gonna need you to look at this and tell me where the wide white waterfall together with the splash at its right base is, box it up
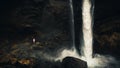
[82,0,117,68]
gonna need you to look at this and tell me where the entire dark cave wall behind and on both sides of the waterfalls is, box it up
[0,0,120,66]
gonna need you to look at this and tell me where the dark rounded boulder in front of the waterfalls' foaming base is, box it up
[62,57,87,68]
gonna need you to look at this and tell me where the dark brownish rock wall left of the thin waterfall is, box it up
[0,0,72,62]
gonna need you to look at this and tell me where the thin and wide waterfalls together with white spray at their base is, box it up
[55,0,117,68]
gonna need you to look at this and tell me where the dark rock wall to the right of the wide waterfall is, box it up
[93,0,120,56]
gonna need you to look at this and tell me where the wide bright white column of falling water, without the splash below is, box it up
[82,0,93,61]
